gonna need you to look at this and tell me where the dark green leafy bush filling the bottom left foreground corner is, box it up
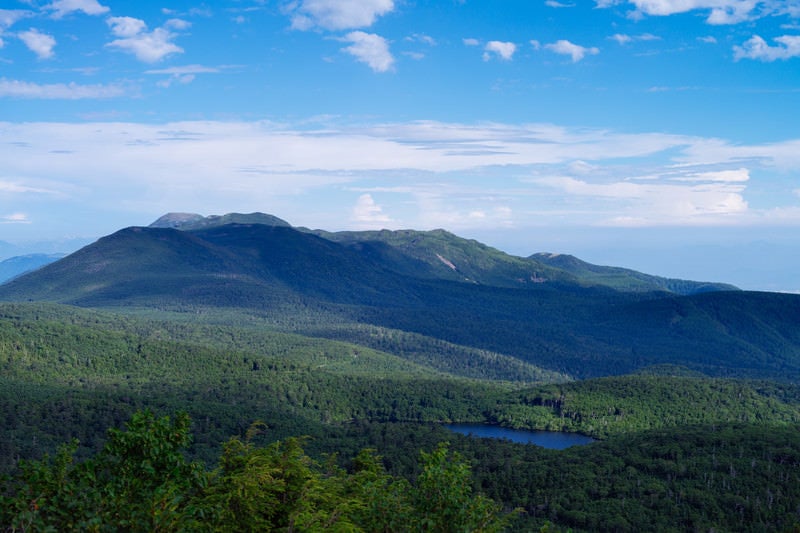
[0,411,206,531]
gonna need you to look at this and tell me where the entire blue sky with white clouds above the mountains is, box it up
[0,0,800,292]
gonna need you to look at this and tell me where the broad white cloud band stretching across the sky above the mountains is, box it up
[0,119,800,228]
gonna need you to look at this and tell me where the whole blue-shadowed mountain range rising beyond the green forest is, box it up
[0,213,800,379]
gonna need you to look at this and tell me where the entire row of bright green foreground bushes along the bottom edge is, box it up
[0,412,509,532]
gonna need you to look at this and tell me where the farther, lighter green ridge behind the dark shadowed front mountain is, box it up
[148,212,739,295]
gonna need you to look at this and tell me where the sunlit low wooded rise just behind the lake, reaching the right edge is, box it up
[491,375,800,437]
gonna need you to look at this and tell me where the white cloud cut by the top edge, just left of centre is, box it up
[288,0,394,31]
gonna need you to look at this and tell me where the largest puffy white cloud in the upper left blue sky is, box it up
[106,17,183,63]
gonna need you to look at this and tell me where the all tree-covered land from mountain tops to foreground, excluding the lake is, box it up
[0,216,800,532]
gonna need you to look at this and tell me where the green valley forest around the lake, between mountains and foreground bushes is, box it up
[0,304,800,531]
